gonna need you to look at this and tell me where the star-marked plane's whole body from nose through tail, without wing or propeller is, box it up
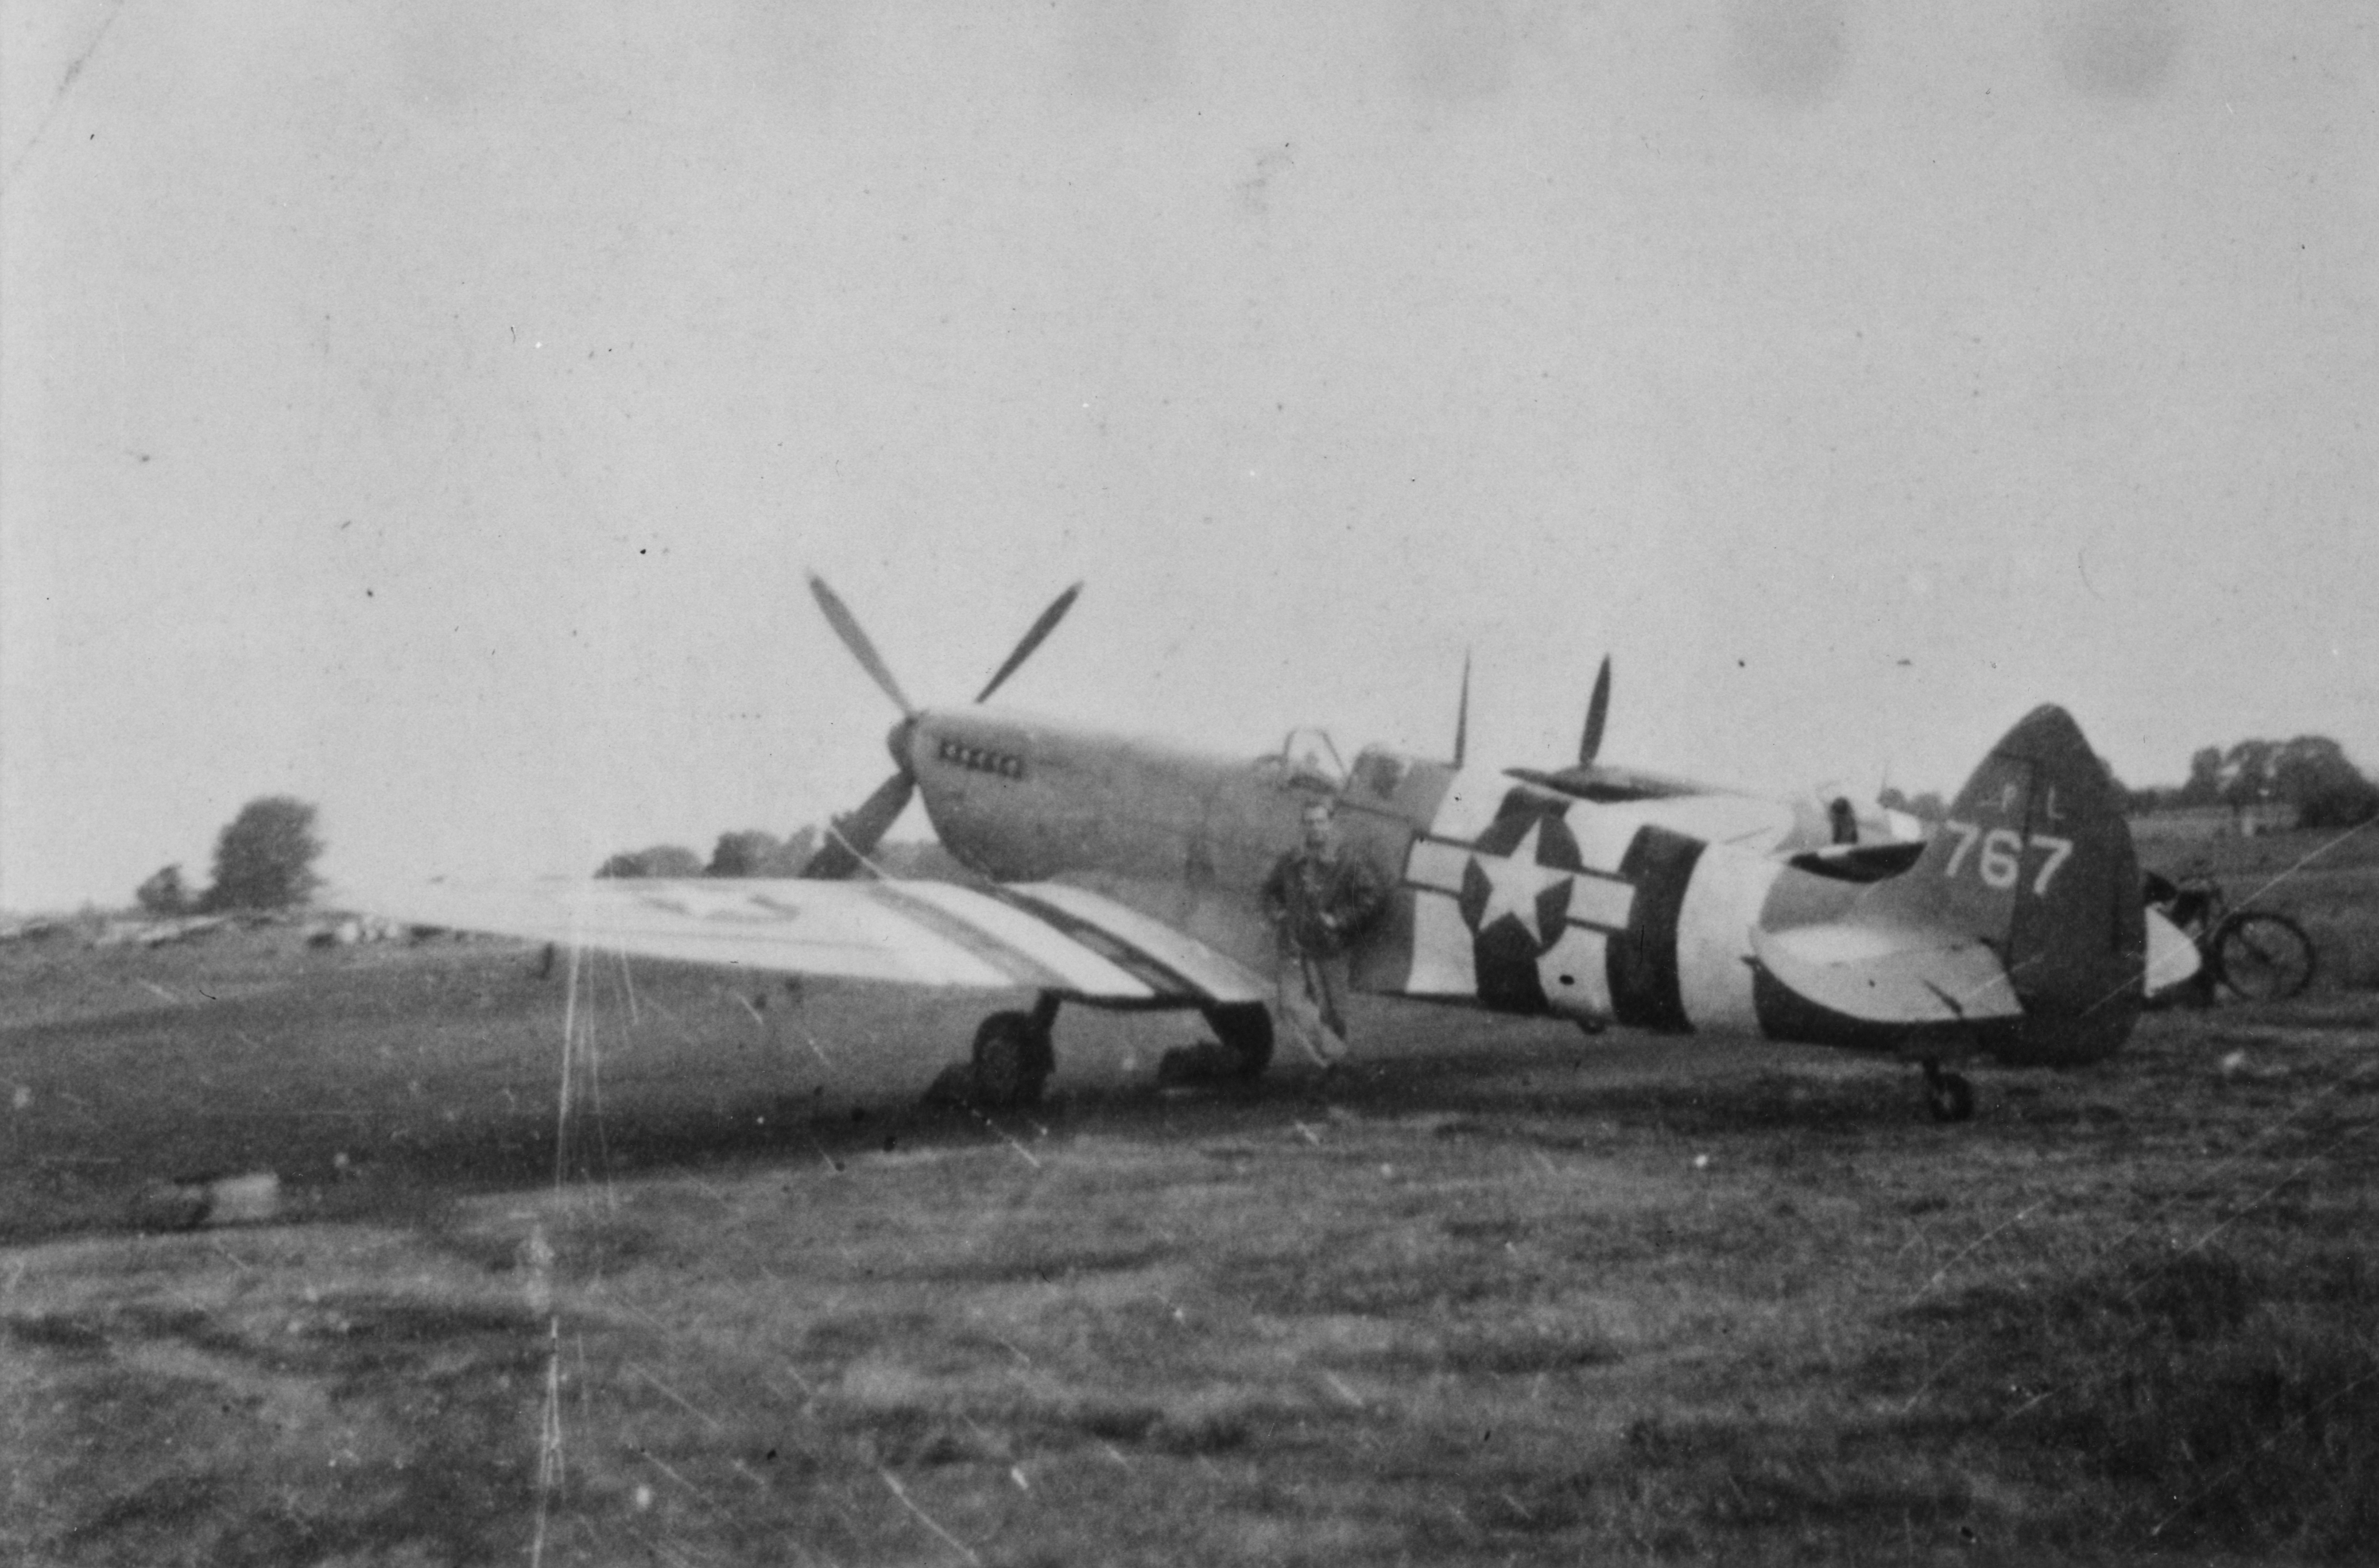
[897,707,2148,1064]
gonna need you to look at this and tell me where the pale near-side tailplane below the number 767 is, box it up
[1751,923,2024,1028]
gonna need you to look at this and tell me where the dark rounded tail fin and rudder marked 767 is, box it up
[1851,707,2148,1064]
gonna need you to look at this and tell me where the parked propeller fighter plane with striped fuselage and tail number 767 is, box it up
[371,576,2196,1121]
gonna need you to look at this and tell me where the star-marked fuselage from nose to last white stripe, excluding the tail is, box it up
[909,707,1903,1056]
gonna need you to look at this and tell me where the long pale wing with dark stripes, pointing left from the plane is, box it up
[340,878,1270,1006]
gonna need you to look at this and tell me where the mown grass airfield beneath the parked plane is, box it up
[0,840,2379,1566]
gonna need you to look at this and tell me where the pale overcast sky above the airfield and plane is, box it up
[0,0,2379,909]
